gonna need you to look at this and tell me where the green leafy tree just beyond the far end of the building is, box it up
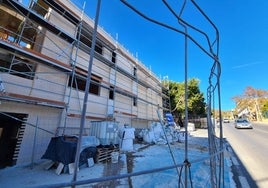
[169,78,206,121]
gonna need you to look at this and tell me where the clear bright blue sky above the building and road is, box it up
[73,0,268,110]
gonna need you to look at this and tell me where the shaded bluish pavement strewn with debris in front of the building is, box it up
[0,129,233,188]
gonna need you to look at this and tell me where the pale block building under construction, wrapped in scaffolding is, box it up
[0,0,169,168]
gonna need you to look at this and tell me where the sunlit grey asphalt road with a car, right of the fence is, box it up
[223,122,268,188]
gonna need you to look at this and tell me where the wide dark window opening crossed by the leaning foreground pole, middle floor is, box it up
[68,72,101,95]
